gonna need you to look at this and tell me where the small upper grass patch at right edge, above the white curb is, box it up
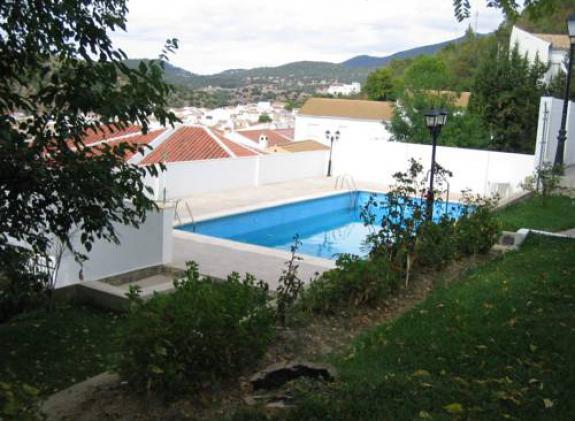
[498,195,575,231]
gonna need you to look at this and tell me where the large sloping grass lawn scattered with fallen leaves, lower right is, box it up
[278,237,575,421]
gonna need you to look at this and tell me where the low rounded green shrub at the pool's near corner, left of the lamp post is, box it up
[302,254,399,313]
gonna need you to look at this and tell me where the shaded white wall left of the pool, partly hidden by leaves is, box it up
[56,207,174,288]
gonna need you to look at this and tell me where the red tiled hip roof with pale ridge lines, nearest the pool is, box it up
[140,126,256,165]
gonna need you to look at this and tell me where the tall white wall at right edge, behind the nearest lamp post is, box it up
[535,97,575,166]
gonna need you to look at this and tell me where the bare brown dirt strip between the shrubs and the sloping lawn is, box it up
[40,251,493,421]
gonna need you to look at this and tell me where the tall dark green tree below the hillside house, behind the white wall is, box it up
[470,44,546,153]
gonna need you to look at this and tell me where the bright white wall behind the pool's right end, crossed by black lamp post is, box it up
[333,141,534,195]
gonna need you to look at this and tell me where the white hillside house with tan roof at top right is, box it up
[509,26,569,83]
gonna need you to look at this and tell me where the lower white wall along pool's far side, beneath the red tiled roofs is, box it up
[145,151,329,200]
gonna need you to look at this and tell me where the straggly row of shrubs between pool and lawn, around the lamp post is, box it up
[302,160,500,313]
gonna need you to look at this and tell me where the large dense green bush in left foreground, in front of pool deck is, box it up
[120,262,274,395]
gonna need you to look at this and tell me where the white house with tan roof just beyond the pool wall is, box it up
[294,98,394,145]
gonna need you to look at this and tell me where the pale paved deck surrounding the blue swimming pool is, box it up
[172,177,387,290]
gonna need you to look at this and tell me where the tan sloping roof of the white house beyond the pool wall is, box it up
[299,98,394,121]
